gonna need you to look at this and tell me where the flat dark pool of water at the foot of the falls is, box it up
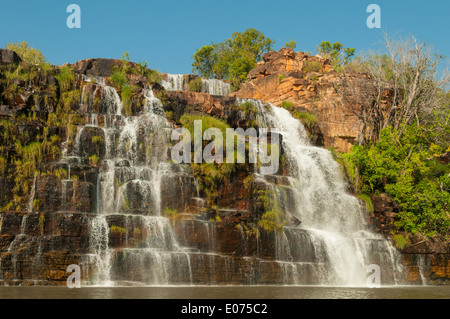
[0,286,450,299]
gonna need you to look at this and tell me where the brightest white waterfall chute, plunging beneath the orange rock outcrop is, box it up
[268,105,398,286]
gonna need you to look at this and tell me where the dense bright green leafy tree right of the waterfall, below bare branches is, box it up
[341,122,450,239]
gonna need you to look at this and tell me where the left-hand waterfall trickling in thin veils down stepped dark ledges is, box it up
[63,77,192,286]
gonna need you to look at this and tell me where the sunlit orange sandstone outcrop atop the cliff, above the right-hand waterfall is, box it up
[231,48,370,152]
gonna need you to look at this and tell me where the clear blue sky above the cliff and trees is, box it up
[0,0,450,73]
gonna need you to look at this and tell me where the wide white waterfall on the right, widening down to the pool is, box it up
[243,100,408,286]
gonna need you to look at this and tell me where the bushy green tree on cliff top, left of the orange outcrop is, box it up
[192,28,275,85]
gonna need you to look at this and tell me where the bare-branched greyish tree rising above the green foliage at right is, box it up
[340,35,449,144]
